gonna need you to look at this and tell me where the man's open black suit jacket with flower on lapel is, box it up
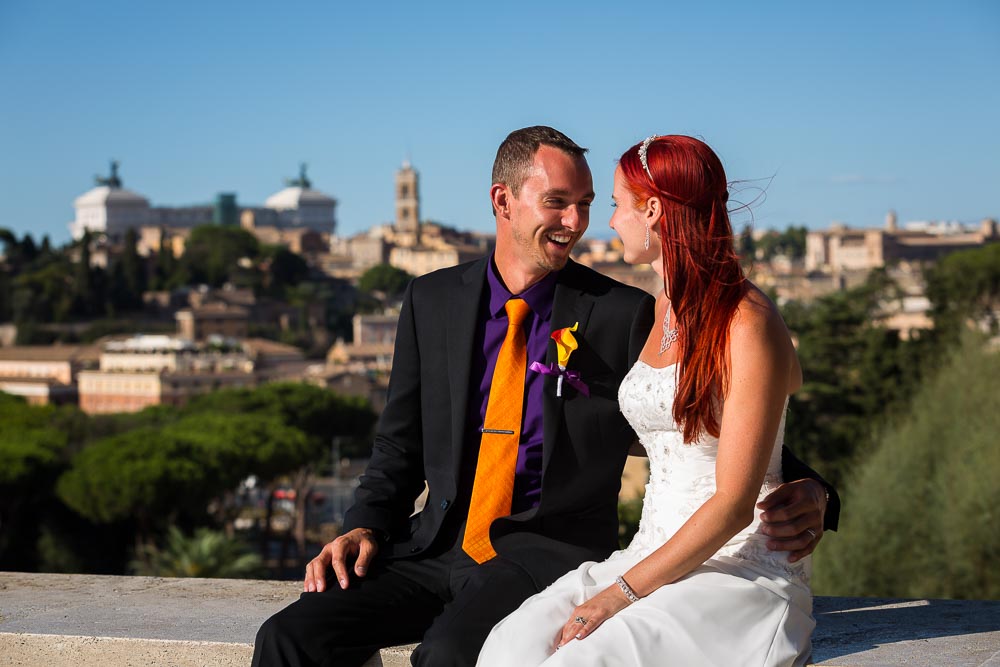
[344,257,840,588]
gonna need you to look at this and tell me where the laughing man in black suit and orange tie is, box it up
[253,127,838,666]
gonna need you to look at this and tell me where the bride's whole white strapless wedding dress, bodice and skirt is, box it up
[478,361,815,667]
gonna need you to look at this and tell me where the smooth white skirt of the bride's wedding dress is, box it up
[478,552,815,667]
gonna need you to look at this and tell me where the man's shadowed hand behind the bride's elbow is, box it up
[757,479,826,563]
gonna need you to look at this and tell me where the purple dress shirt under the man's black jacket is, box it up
[466,259,558,514]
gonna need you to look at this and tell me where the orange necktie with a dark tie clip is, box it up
[462,299,531,563]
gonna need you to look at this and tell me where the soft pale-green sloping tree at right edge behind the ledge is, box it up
[814,334,1000,599]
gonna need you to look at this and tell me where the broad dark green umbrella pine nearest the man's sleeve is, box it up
[56,383,374,568]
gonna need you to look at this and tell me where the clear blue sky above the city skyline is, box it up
[0,0,1000,242]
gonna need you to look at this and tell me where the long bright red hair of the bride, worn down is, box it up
[619,135,748,443]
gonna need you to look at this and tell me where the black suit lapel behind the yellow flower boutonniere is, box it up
[542,261,594,475]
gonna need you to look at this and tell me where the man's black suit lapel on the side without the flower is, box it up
[445,256,489,484]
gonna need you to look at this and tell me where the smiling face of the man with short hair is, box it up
[498,146,594,271]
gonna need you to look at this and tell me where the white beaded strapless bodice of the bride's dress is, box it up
[618,361,808,584]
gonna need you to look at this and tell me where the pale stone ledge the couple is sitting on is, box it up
[0,572,1000,667]
